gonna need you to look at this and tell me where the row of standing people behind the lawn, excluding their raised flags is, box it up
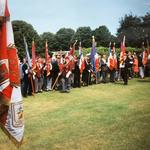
[20,49,150,97]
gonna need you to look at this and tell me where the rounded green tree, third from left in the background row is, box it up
[55,28,75,51]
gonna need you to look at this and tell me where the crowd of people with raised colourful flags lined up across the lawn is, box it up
[20,36,150,97]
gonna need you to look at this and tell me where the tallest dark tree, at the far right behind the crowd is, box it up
[117,13,150,47]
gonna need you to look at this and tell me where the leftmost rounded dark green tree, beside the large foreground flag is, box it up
[12,20,41,57]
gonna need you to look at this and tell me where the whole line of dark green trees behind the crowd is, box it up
[13,13,150,57]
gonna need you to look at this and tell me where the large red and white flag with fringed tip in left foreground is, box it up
[0,0,24,147]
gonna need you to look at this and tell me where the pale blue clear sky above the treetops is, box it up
[8,0,150,35]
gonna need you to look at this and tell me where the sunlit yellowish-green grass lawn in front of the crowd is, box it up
[0,78,150,150]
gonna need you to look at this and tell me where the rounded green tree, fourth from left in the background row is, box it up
[73,27,92,48]
